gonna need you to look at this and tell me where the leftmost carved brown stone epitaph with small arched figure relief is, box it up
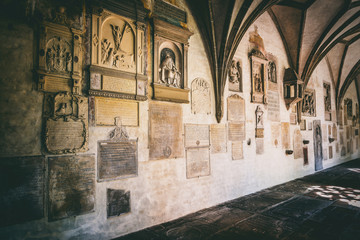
[37,22,82,94]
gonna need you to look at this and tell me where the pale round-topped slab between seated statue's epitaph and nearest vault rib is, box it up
[191,78,211,114]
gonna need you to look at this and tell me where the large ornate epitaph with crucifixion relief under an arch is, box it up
[89,6,147,101]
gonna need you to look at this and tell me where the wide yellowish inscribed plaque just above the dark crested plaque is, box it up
[95,97,139,126]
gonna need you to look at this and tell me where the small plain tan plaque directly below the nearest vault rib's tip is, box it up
[210,124,227,153]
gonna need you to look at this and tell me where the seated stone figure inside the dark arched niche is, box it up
[159,48,181,88]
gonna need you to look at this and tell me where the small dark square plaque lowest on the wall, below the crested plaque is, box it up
[106,188,131,218]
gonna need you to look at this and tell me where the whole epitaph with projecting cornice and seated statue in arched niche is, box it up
[152,16,192,103]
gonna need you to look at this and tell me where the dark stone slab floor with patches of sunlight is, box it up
[117,159,360,240]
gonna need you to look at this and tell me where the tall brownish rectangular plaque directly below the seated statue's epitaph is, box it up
[149,102,183,160]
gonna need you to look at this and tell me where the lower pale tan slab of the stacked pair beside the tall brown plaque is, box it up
[186,147,210,178]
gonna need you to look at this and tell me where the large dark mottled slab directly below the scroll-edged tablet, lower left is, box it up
[48,155,95,221]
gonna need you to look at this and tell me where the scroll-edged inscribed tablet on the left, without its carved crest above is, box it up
[45,117,88,154]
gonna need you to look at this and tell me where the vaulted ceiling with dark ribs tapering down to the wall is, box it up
[186,0,360,122]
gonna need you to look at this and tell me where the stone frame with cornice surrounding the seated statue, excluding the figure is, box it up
[152,18,193,103]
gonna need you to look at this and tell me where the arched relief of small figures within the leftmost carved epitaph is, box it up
[46,37,72,72]
